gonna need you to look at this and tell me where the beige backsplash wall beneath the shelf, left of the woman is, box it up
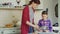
[0,10,22,27]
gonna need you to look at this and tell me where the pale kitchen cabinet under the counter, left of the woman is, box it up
[0,27,20,34]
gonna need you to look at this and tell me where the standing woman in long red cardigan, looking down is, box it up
[21,0,40,34]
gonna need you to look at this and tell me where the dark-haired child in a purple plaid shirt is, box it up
[38,11,52,32]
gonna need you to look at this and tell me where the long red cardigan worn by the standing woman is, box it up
[21,6,35,34]
